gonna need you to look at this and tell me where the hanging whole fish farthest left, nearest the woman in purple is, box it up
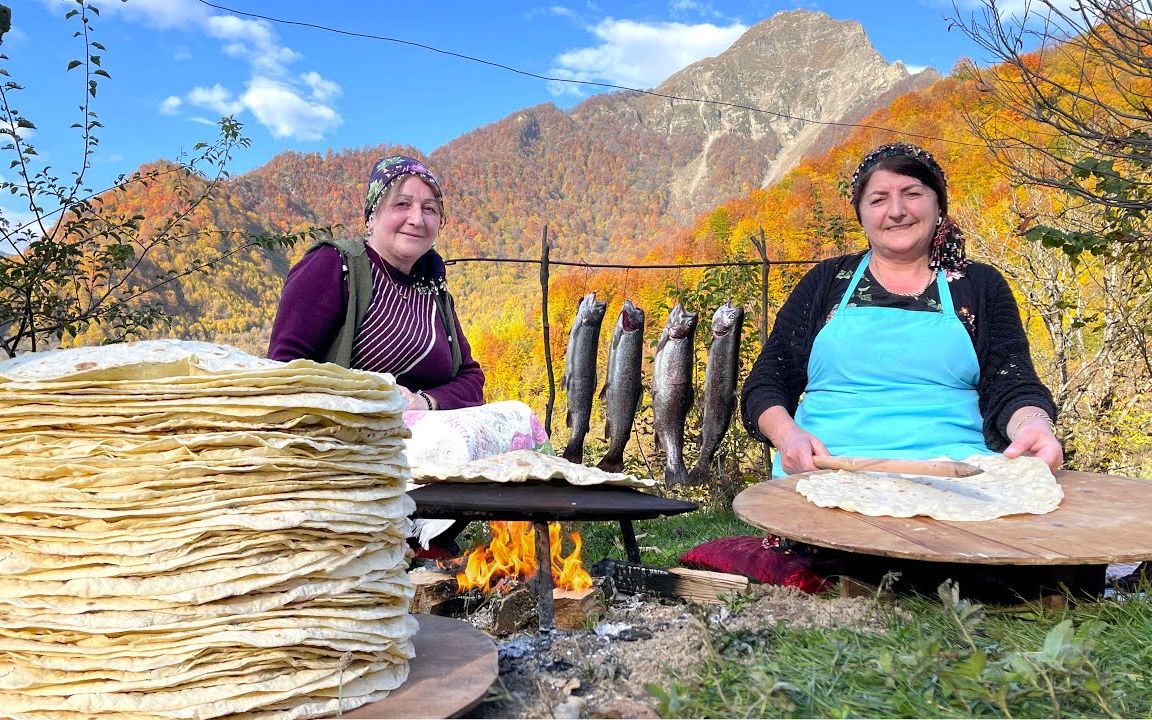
[560,293,607,463]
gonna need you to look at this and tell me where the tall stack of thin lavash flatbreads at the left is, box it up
[0,341,417,720]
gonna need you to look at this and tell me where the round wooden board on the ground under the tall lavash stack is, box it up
[331,615,499,720]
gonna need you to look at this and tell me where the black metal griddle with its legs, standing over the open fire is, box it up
[408,482,698,630]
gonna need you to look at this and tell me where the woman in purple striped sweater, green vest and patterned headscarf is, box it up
[268,156,484,410]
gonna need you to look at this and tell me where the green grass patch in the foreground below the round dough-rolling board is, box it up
[649,586,1152,718]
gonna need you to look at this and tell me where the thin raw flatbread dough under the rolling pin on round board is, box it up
[796,455,1064,521]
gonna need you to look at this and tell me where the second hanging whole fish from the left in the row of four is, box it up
[597,300,644,472]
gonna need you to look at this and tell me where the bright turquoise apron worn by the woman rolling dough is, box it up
[773,252,992,477]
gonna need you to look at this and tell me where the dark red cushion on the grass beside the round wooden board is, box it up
[680,535,831,592]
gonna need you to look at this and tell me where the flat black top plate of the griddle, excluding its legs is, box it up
[408,483,697,522]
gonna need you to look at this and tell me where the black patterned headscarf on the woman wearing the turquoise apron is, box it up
[852,143,971,278]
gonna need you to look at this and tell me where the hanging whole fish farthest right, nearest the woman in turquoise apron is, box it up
[688,302,744,485]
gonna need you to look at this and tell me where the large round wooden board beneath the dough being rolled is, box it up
[733,470,1152,566]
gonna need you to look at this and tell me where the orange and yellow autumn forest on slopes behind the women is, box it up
[4,7,1152,484]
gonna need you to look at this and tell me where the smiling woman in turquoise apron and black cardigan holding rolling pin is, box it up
[742,143,1063,477]
